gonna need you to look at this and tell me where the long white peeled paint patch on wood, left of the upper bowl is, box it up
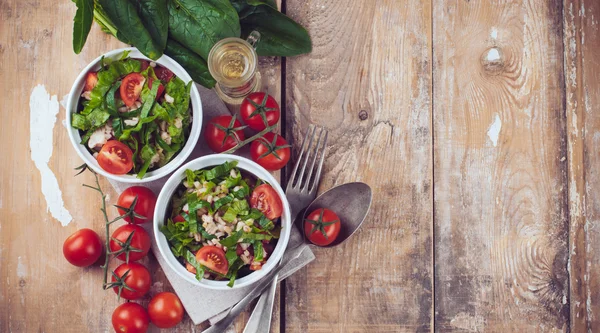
[29,84,73,226]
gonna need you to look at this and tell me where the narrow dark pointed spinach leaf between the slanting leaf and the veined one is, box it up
[131,0,169,50]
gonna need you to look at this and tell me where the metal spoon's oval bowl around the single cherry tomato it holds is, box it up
[301,182,373,247]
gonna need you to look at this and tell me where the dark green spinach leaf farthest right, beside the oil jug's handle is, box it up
[240,4,312,57]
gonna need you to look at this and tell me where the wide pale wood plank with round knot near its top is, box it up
[433,0,569,332]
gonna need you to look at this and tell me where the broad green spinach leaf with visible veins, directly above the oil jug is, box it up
[168,0,240,59]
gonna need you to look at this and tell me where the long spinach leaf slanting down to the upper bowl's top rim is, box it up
[98,0,164,60]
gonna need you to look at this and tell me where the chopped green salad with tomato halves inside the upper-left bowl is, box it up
[71,52,192,179]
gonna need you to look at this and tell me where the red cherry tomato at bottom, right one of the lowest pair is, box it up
[148,292,183,328]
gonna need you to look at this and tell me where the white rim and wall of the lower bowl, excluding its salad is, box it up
[153,154,292,290]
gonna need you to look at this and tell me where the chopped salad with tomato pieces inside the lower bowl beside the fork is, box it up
[161,162,283,287]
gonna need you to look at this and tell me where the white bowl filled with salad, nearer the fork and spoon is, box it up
[155,155,290,288]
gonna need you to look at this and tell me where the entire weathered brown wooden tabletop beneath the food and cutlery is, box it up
[0,0,600,333]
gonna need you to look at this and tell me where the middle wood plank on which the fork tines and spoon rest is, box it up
[285,0,432,333]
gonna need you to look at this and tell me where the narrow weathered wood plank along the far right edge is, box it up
[563,0,600,332]
